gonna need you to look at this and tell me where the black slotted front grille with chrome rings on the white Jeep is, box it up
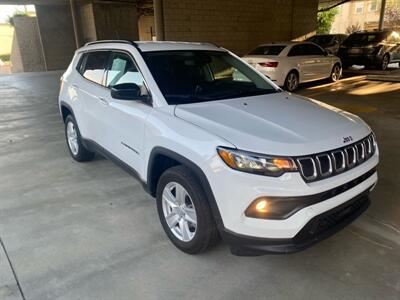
[296,134,376,182]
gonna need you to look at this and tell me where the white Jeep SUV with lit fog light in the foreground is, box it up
[59,41,378,255]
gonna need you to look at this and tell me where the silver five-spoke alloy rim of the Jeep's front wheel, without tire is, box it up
[162,182,197,242]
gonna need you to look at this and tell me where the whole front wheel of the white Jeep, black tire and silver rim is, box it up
[156,166,218,254]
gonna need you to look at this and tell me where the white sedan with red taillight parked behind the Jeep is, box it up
[243,42,342,92]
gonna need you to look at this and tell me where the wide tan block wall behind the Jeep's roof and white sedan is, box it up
[163,0,318,54]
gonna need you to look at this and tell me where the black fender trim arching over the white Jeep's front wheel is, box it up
[147,147,225,231]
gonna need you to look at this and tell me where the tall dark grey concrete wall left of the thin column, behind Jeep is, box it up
[35,4,76,71]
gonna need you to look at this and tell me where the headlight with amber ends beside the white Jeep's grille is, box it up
[217,147,297,177]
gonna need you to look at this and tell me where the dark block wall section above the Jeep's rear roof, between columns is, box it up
[92,2,139,40]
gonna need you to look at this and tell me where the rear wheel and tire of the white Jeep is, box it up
[64,115,94,162]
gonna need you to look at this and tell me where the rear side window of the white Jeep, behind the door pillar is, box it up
[81,51,110,84]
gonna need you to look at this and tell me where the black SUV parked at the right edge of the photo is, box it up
[338,30,400,70]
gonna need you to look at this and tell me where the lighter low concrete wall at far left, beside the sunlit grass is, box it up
[11,16,46,73]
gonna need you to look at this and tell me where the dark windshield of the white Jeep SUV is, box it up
[143,50,279,104]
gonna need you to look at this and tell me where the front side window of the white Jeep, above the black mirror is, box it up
[106,52,146,94]
